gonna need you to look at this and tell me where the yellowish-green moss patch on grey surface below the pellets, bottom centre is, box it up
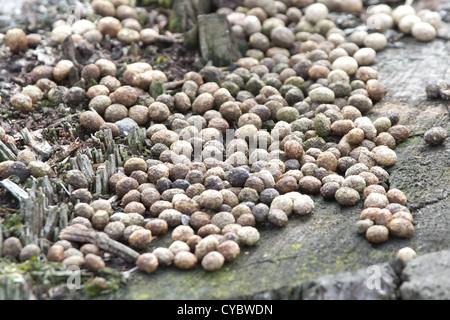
[116,235,400,299]
